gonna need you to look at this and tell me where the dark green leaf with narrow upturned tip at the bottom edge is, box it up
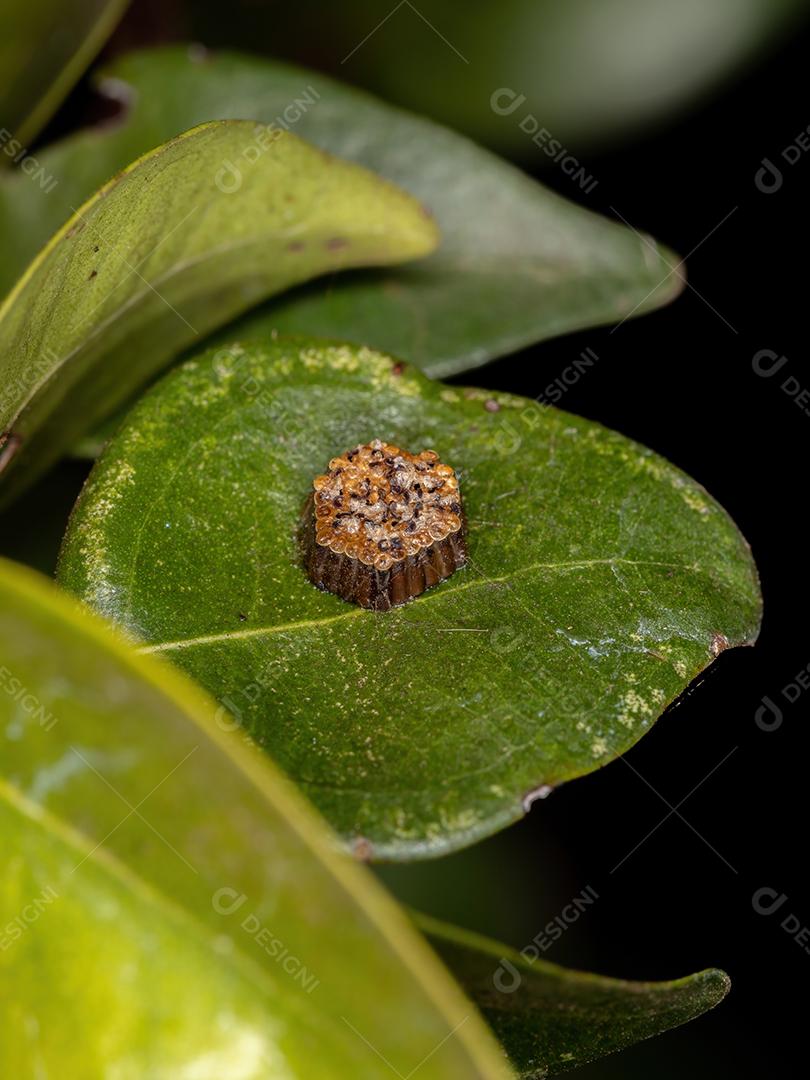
[416,915,730,1080]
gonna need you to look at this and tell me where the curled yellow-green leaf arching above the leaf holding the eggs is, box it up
[0,121,436,499]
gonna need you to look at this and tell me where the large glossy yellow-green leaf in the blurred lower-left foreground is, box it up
[0,561,505,1080]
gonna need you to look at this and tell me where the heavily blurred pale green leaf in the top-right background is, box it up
[328,0,808,157]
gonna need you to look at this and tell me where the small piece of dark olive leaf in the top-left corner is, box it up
[0,0,127,152]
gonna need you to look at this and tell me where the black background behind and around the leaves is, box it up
[2,0,810,1080]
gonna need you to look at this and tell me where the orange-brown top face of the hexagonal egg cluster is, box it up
[313,438,463,570]
